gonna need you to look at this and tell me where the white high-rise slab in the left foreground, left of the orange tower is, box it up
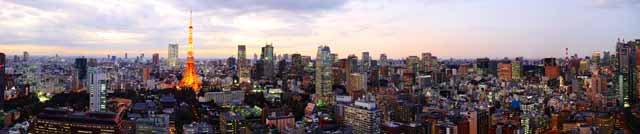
[87,67,108,112]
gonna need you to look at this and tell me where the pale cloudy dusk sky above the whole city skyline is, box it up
[0,0,640,59]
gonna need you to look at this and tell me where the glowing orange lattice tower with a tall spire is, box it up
[180,10,200,94]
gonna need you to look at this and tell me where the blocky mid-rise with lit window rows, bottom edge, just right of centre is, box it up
[344,97,382,134]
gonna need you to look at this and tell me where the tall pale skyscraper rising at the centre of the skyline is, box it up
[315,46,333,104]
